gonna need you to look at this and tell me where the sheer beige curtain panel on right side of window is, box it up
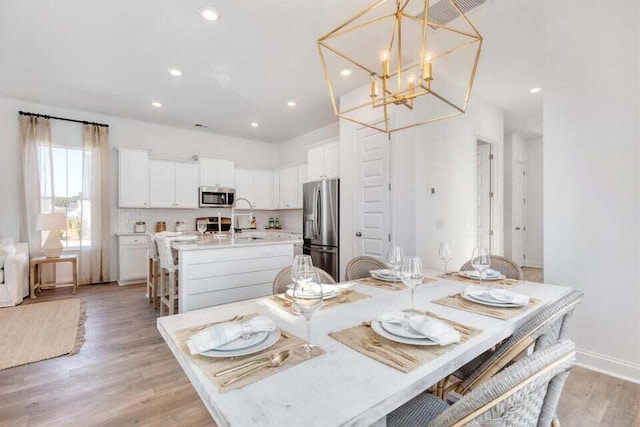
[78,124,111,284]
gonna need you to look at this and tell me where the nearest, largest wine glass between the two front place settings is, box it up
[292,271,324,358]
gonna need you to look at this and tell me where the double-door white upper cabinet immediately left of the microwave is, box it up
[149,160,199,209]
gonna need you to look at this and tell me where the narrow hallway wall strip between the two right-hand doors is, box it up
[504,133,529,259]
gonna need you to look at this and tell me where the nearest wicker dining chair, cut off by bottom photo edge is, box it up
[387,340,576,427]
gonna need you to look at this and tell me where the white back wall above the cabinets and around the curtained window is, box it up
[0,97,277,280]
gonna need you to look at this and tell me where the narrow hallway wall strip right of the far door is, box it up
[524,138,544,268]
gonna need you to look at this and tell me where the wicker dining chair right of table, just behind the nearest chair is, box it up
[436,290,584,398]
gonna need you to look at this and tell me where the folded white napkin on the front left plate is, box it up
[187,316,276,354]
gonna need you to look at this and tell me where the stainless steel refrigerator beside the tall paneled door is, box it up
[302,179,340,282]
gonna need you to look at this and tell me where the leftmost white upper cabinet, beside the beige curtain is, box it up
[118,148,149,208]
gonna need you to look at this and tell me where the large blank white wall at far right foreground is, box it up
[541,0,640,381]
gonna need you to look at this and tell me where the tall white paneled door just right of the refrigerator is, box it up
[353,128,391,259]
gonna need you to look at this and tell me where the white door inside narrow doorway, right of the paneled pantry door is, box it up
[476,141,491,253]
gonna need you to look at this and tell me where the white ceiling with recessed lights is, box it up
[0,0,542,143]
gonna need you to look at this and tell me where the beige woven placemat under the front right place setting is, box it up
[329,312,482,372]
